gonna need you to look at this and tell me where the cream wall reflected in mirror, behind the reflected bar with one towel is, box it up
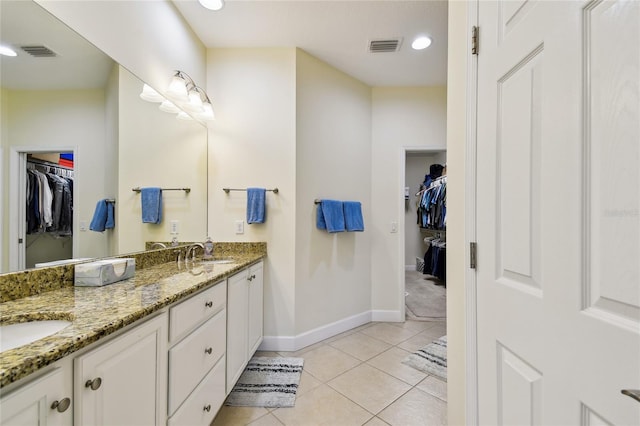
[112,67,207,253]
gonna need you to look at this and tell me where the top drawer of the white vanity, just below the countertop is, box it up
[169,281,227,342]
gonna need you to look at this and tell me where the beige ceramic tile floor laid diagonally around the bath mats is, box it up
[212,320,447,426]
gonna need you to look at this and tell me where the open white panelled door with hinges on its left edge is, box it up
[477,0,640,425]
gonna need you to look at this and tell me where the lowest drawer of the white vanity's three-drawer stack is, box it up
[168,357,225,426]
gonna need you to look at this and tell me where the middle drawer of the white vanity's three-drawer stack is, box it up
[169,309,227,414]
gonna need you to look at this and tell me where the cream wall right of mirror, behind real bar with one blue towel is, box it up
[206,48,296,336]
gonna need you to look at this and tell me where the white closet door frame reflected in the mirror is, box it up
[8,146,78,272]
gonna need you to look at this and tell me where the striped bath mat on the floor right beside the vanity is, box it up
[225,357,304,407]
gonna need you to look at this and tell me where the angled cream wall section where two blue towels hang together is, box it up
[295,50,373,334]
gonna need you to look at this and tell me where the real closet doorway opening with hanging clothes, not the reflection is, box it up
[401,149,447,321]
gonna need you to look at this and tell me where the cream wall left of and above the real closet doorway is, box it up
[369,87,446,321]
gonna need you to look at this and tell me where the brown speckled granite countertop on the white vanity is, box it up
[0,253,265,388]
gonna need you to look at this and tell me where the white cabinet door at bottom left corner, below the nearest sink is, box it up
[0,365,73,426]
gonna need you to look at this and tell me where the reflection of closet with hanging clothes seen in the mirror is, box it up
[23,152,74,268]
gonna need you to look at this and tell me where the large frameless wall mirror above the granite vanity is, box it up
[0,0,207,272]
